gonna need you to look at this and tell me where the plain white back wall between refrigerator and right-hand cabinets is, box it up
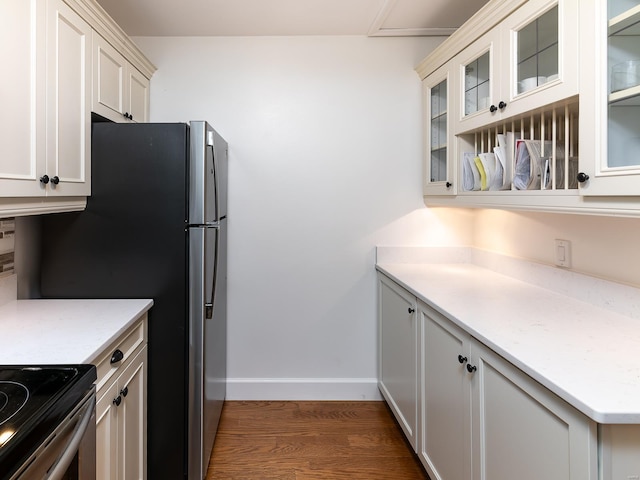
[135,37,472,399]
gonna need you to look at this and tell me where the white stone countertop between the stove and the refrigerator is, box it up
[0,299,153,365]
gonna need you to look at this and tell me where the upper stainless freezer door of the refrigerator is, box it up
[189,122,228,225]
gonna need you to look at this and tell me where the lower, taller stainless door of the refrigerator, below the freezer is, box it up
[188,220,227,479]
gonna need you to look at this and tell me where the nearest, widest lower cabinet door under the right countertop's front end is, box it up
[470,341,597,480]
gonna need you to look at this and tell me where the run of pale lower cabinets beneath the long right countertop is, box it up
[378,275,596,480]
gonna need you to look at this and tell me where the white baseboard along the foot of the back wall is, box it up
[227,378,382,401]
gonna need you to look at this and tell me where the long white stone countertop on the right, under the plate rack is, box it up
[377,263,640,424]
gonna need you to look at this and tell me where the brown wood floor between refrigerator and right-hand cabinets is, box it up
[206,402,429,480]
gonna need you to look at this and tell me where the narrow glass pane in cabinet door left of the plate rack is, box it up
[429,80,447,182]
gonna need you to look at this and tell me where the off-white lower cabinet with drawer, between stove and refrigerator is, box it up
[96,316,147,480]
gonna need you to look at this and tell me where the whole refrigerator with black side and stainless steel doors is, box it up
[40,122,228,480]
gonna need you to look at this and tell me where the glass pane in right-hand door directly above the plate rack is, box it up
[517,6,559,93]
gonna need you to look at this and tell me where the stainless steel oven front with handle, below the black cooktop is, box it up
[11,387,96,480]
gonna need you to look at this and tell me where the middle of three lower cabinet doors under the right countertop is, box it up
[419,304,471,480]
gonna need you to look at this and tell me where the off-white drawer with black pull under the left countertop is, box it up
[96,314,147,392]
